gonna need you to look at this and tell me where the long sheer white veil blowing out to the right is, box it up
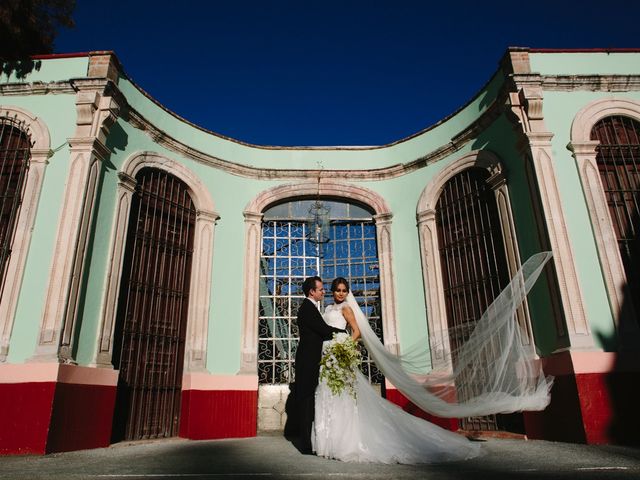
[347,252,553,418]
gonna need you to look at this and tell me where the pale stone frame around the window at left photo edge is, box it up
[0,106,51,362]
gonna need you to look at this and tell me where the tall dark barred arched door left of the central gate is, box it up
[112,168,196,441]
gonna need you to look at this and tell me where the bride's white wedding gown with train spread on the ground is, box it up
[311,302,480,464]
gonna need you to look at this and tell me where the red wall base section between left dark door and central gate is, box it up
[180,390,258,440]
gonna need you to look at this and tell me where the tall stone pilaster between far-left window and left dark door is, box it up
[32,89,119,362]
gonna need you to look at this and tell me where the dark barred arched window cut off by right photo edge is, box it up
[591,115,640,322]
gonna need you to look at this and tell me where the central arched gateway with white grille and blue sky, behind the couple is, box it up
[257,200,384,430]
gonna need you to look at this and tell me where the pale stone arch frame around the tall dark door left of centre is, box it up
[93,152,220,373]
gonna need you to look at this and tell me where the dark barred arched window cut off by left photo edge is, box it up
[0,117,31,299]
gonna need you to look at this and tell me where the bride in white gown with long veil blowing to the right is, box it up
[311,252,553,463]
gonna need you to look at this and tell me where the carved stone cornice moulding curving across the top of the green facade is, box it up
[0,72,640,181]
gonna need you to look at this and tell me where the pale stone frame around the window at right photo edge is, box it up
[567,98,640,348]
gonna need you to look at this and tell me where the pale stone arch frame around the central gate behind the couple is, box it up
[240,182,398,375]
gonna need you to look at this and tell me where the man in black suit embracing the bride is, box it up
[294,277,344,453]
